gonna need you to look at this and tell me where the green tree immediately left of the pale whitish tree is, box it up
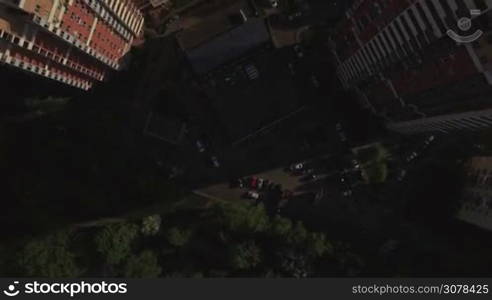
[95,223,138,265]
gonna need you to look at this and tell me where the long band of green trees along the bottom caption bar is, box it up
[6,202,354,278]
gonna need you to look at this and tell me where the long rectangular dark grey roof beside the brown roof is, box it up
[187,19,270,74]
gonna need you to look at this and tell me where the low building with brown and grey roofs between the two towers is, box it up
[176,0,271,75]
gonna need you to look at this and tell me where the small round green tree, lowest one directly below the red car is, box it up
[230,240,262,270]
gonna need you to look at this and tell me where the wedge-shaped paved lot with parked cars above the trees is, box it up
[195,150,358,212]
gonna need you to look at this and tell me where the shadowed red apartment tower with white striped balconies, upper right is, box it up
[330,0,492,133]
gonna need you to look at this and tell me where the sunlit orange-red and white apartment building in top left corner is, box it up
[0,0,144,90]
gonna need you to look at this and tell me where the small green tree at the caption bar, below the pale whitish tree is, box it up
[124,250,162,278]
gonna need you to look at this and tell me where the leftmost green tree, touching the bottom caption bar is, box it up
[17,232,81,278]
